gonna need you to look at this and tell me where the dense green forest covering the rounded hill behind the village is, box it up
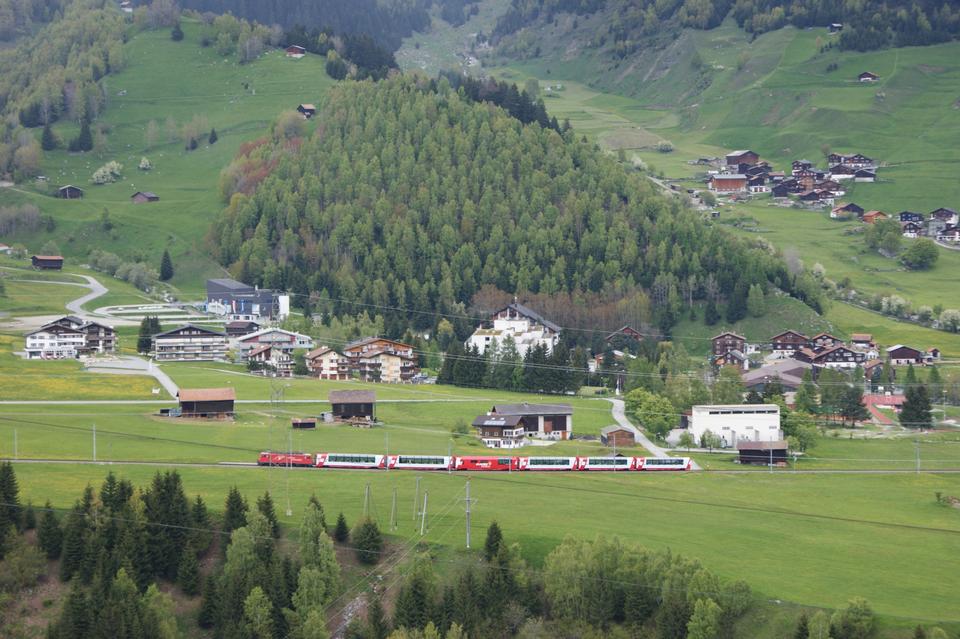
[211,76,819,327]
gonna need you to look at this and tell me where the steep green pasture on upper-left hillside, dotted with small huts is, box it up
[0,21,332,296]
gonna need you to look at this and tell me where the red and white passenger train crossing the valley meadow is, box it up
[257,452,692,472]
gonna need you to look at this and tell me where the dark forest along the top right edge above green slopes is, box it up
[493,0,960,55]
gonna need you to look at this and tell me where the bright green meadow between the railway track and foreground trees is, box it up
[16,464,960,621]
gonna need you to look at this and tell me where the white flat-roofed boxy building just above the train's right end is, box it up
[689,404,783,448]
